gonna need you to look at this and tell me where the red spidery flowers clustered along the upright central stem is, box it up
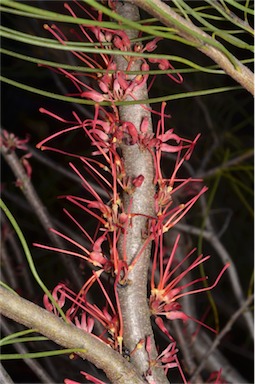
[35,1,228,384]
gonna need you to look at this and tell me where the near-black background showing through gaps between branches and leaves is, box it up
[1,1,253,383]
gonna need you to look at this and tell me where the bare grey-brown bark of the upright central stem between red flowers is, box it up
[115,2,168,383]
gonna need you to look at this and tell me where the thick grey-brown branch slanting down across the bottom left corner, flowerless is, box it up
[0,287,145,384]
